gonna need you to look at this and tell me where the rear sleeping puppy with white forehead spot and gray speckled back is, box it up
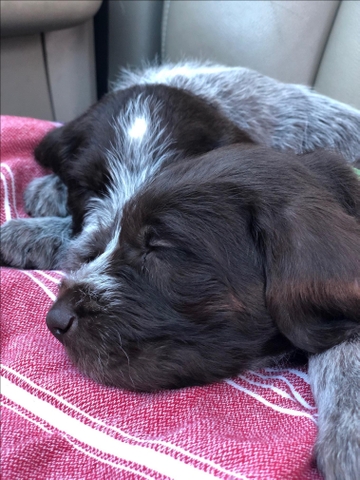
[0,63,360,269]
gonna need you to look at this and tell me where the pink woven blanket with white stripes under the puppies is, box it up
[0,117,321,480]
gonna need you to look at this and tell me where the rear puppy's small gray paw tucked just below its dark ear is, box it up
[24,174,68,217]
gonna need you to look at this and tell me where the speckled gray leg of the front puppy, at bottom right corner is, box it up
[309,337,360,480]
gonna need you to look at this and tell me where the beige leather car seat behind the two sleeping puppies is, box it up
[1,0,360,122]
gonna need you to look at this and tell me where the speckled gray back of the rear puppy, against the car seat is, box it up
[114,62,360,162]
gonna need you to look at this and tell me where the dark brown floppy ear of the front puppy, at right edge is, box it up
[257,191,360,353]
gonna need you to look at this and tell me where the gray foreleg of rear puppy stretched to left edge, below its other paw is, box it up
[0,216,71,270]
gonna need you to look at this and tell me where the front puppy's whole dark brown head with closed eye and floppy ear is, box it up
[48,146,360,390]
